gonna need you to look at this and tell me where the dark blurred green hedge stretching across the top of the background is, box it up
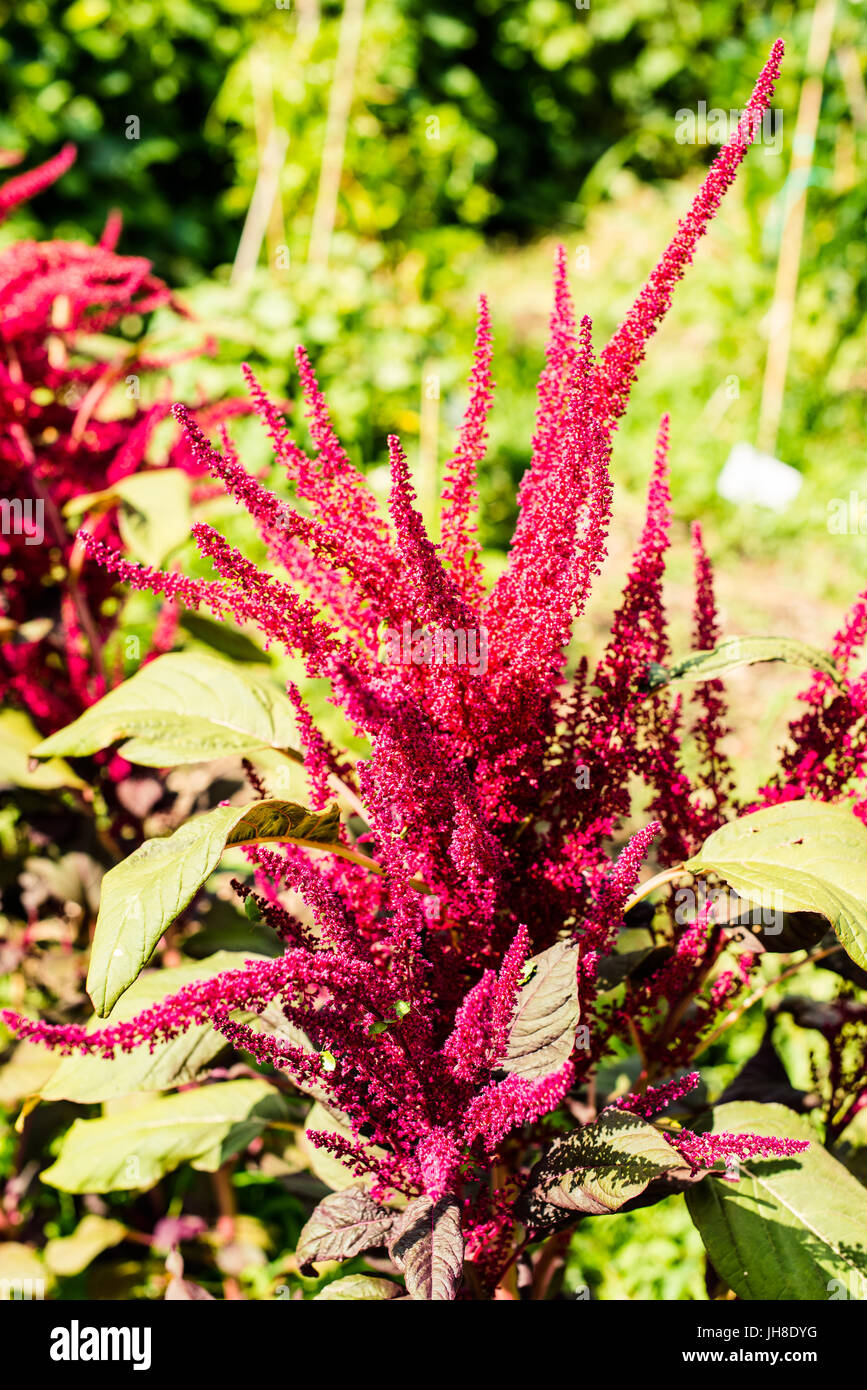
[0,0,864,279]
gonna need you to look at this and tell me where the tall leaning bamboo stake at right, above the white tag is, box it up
[757,0,836,455]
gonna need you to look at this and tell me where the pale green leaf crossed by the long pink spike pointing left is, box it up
[39,951,263,1105]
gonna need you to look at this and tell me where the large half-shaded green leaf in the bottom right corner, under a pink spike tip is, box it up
[686,1101,867,1302]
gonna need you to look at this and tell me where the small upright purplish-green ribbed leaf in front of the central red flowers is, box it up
[497,941,581,1079]
